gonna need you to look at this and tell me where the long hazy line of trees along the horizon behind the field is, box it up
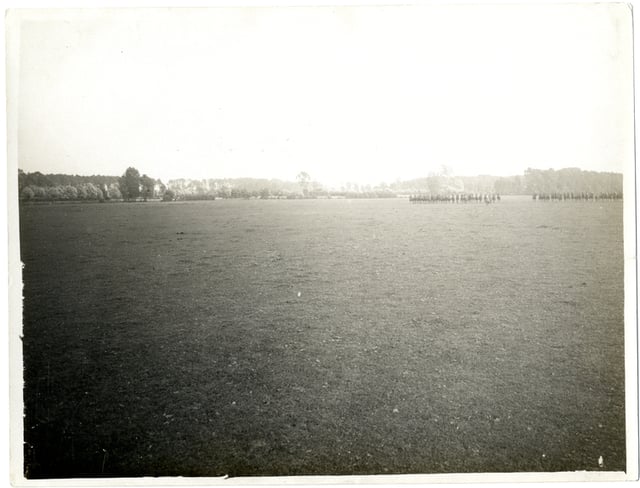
[18,167,622,201]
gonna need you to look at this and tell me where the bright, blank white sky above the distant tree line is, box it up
[8,4,633,185]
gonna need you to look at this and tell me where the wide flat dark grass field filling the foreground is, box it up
[20,199,625,478]
